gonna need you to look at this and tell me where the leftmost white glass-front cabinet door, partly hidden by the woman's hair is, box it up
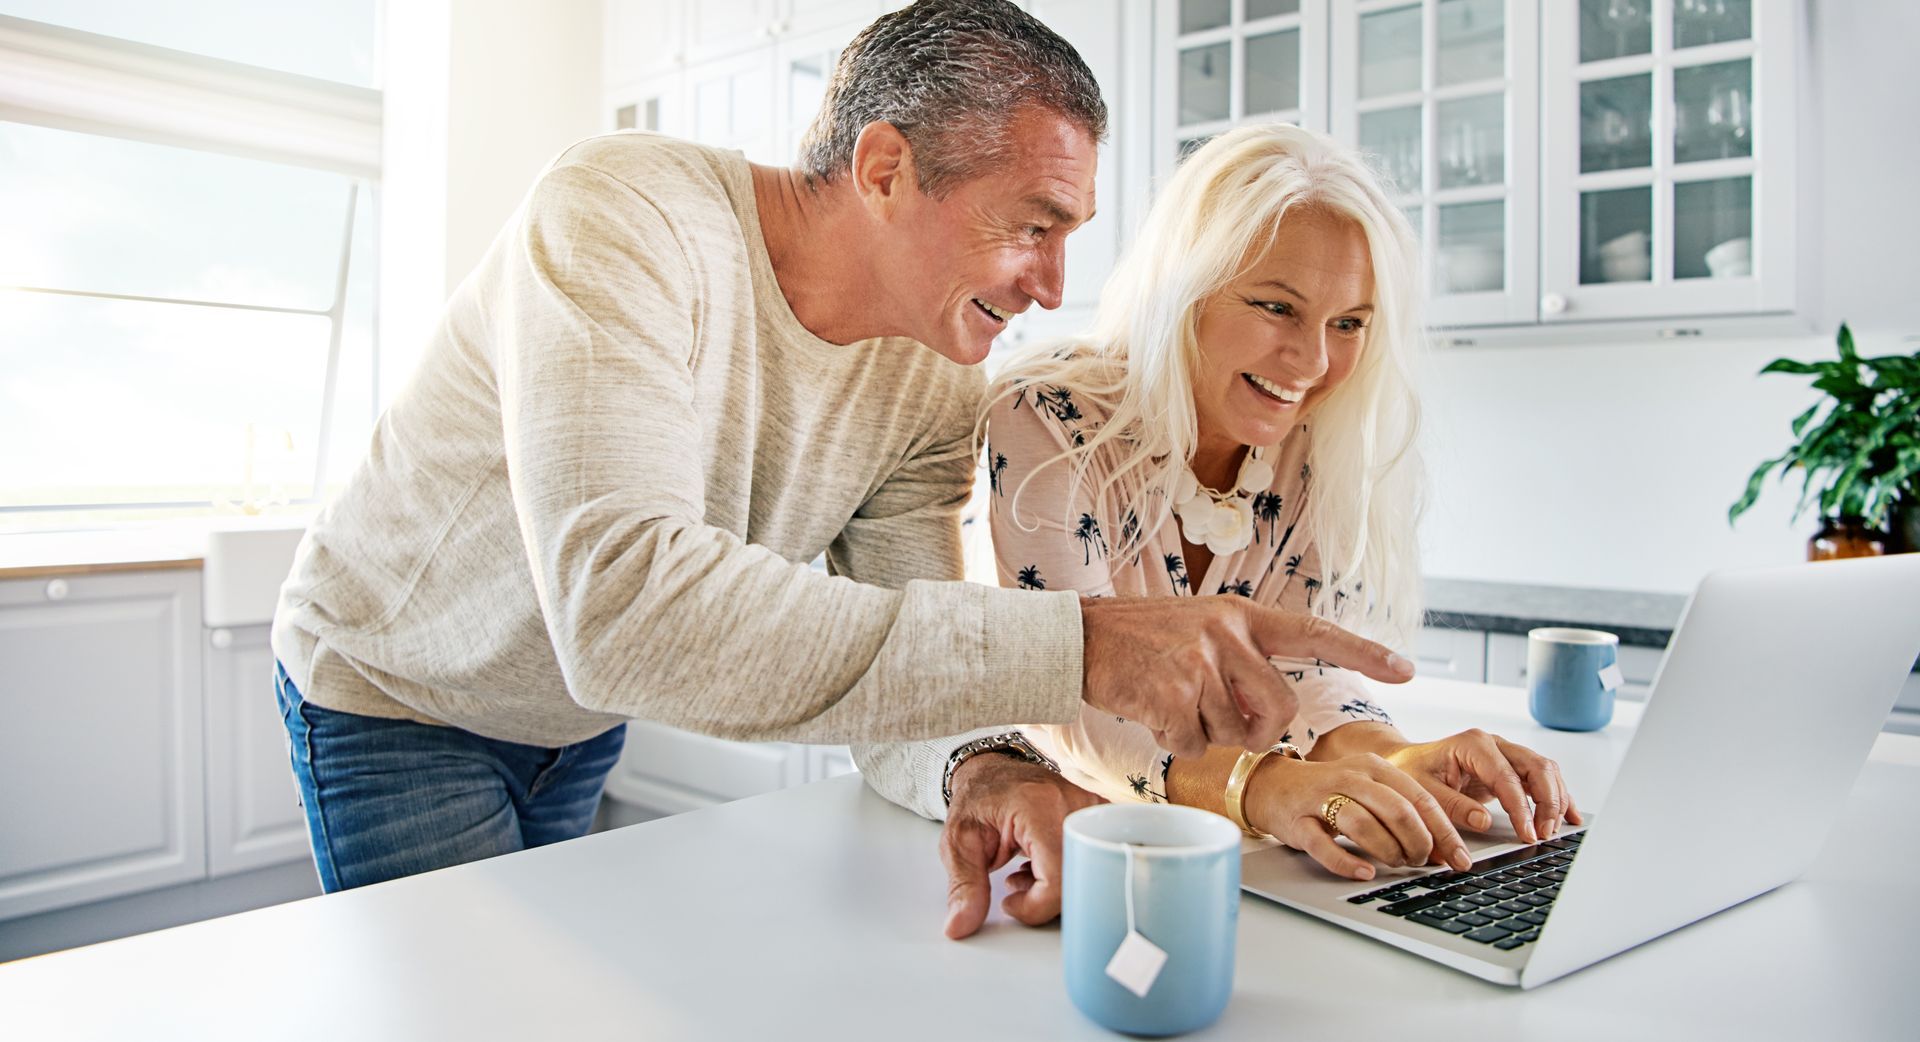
[1152,0,1329,180]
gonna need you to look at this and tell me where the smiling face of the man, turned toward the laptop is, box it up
[881,107,1096,365]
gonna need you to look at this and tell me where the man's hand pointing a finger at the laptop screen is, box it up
[1081,595,1413,756]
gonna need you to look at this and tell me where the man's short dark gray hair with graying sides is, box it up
[799,0,1106,198]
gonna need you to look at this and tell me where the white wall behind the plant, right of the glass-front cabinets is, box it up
[1423,0,1920,593]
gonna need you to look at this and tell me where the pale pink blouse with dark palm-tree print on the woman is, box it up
[985,384,1392,802]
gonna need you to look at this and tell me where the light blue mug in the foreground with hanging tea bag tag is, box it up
[1060,804,1240,1034]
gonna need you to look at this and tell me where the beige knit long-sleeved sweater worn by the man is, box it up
[273,134,1081,746]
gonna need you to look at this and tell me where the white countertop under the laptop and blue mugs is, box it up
[0,679,1920,1042]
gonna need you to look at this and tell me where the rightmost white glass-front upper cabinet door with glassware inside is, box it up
[1540,0,1799,322]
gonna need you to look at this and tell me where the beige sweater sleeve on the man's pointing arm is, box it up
[492,165,1081,741]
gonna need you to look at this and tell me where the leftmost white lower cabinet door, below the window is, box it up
[0,570,205,919]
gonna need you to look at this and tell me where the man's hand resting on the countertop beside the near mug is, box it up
[941,752,1106,940]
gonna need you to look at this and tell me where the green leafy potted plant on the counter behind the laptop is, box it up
[1726,322,1920,560]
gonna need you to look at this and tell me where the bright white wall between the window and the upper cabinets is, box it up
[380,0,601,401]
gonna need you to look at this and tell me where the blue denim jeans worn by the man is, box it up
[273,662,626,892]
